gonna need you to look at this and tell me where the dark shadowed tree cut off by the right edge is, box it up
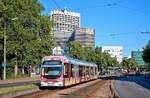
[143,41,150,68]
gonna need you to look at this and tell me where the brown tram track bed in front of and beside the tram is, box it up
[14,80,111,98]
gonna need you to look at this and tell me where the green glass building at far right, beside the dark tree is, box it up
[131,50,145,68]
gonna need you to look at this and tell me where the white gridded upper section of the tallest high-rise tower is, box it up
[51,9,80,32]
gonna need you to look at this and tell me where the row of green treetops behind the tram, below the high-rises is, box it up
[68,41,118,69]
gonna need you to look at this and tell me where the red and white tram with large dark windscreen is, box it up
[40,55,98,87]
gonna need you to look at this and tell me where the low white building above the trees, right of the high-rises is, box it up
[102,46,123,63]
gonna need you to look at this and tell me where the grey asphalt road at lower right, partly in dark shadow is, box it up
[114,76,150,98]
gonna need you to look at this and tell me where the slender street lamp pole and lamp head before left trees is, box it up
[3,17,18,80]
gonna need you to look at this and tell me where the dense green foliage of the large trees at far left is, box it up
[0,0,54,71]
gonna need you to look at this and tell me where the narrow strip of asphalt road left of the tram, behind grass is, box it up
[0,80,40,88]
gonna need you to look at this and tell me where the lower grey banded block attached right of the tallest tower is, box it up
[74,28,95,47]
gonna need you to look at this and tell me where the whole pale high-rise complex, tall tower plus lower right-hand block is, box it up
[51,9,95,48]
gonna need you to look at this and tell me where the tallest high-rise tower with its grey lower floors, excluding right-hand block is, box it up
[51,9,80,47]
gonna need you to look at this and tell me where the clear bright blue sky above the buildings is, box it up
[39,0,150,57]
